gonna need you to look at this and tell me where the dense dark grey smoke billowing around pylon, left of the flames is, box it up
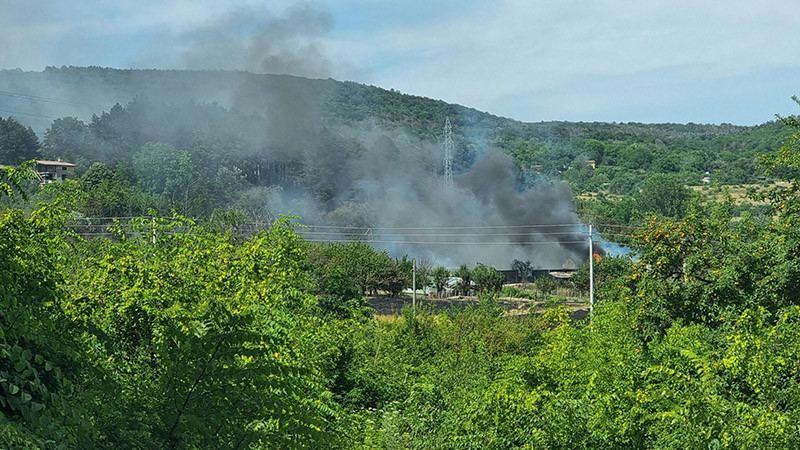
[239,98,587,268]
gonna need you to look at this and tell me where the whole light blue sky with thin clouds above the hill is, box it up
[0,0,800,124]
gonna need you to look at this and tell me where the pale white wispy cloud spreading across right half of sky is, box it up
[344,1,800,120]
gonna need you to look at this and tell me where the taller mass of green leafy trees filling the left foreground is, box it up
[0,214,335,448]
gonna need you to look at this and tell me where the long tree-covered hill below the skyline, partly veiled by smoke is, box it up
[0,67,790,229]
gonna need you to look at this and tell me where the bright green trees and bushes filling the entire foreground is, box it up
[0,99,800,449]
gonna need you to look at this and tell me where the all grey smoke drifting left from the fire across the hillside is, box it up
[0,68,586,268]
